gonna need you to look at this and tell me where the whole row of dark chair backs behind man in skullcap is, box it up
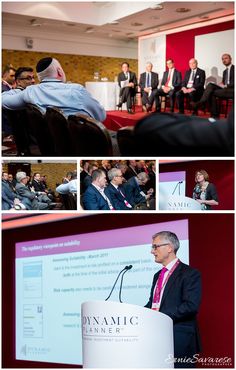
[7,104,113,157]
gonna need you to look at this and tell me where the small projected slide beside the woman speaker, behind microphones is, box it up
[159,171,186,197]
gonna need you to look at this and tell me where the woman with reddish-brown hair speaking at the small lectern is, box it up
[193,170,219,210]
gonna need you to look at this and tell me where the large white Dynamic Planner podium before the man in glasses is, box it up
[81,301,174,368]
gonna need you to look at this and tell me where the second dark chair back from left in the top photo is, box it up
[26,104,55,156]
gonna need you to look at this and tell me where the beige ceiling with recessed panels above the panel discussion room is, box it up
[2,1,234,41]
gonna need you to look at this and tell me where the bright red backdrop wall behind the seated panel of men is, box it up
[166,21,234,78]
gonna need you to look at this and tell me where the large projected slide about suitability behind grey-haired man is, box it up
[15,220,189,365]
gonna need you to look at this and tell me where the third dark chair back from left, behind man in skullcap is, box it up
[46,107,74,157]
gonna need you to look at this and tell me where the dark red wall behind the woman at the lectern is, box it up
[159,160,234,210]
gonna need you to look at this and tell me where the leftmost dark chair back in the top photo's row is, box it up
[4,109,32,156]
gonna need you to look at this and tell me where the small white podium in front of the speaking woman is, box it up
[159,195,201,211]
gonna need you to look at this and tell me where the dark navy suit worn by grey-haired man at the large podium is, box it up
[145,262,201,357]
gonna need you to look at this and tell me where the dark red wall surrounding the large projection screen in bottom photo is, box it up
[2,213,234,368]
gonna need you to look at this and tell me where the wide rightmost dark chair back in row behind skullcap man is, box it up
[68,114,113,157]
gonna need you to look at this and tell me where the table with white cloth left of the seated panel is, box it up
[85,81,120,111]
